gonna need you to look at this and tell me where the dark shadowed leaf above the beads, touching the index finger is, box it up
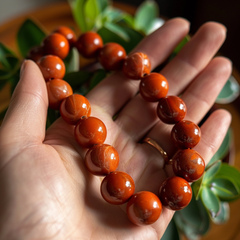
[98,26,144,53]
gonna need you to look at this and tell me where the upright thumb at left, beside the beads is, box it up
[0,60,48,145]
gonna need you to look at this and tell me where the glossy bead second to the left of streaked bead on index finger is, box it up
[75,32,103,58]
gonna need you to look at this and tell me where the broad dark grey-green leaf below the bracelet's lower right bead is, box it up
[174,191,210,239]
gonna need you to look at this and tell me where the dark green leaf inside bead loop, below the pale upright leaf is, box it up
[64,71,92,90]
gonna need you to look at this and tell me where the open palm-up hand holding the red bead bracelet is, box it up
[0,18,231,240]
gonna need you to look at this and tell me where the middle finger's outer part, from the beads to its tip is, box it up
[161,22,226,95]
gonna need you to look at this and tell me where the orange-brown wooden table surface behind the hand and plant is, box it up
[0,2,240,240]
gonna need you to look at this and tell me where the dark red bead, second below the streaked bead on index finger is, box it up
[157,96,187,124]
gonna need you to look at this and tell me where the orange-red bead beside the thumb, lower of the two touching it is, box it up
[46,79,73,110]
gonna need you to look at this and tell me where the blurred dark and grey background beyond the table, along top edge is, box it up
[0,0,240,71]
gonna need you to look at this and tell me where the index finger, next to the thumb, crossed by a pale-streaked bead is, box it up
[87,18,189,116]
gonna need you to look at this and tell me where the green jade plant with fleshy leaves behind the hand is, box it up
[0,0,240,240]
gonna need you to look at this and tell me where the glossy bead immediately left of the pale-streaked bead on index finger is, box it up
[98,43,126,71]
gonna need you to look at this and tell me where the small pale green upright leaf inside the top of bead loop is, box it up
[64,47,80,73]
